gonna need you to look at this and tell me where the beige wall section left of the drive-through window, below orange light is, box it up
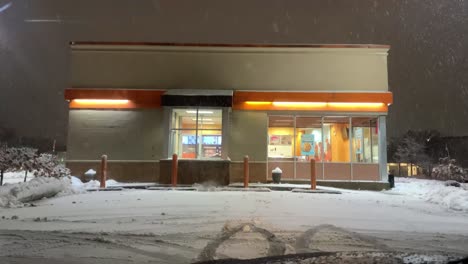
[67,109,167,161]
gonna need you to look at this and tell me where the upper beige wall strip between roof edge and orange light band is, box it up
[71,45,388,91]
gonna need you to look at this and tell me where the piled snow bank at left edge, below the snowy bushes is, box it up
[0,177,84,207]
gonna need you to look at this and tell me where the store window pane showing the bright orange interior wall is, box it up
[322,117,350,162]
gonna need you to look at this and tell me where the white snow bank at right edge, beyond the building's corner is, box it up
[388,178,468,212]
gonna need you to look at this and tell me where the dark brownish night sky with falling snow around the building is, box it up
[0,0,468,147]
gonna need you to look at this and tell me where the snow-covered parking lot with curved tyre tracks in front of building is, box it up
[0,175,468,263]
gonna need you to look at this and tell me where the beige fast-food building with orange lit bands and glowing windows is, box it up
[65,42,393,184]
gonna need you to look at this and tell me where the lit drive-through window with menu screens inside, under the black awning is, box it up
[171,108,222,159]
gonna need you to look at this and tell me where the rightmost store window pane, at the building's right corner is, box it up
[351,117,379,163]
